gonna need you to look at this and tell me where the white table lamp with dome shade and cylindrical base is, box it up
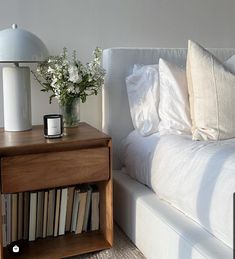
[0,24,49,131]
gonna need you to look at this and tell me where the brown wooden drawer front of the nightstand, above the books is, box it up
[1,147,110,193]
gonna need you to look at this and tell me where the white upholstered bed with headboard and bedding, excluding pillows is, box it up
[102,48,235,259]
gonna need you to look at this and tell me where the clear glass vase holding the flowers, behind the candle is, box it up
[60,98,80,128]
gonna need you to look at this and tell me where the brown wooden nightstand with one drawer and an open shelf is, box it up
[0,123,113,259]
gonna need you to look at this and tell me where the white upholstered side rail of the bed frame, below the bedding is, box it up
[113,170,233,259]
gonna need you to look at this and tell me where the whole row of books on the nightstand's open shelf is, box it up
[2,184,99,247]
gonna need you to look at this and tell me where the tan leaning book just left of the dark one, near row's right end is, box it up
[75,188,87,234]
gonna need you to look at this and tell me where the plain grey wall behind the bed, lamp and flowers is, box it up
[0,0,235,128]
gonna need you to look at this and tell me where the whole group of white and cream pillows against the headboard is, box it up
[126,41,235,140]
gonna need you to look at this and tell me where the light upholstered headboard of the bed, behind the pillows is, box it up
[102,48,235,169]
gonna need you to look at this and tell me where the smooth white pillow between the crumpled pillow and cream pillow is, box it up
[158,59,191,135]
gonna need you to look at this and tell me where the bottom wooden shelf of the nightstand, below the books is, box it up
[3,231,111,259]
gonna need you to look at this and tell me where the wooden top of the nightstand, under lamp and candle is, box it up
[0,122,110,156]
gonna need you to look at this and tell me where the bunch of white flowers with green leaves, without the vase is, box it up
[33,47,105,106]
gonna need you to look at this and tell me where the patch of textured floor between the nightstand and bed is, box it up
[70,225,146,259]
